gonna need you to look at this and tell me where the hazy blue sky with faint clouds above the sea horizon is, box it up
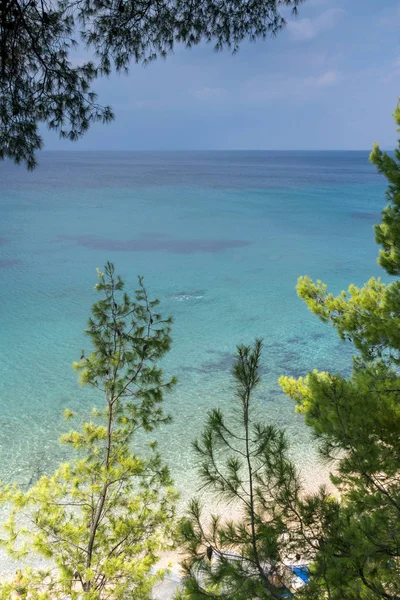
[43,0,400,150]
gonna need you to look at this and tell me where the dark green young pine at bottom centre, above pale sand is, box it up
[181,341,324,600]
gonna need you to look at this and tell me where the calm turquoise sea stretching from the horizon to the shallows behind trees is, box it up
[0,152,385,491]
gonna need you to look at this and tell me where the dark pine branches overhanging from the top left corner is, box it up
[0,0,302,168]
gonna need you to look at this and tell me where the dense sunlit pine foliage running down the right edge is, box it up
[280,108,400,600]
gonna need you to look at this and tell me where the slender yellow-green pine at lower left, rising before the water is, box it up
[0,263,176,600]
